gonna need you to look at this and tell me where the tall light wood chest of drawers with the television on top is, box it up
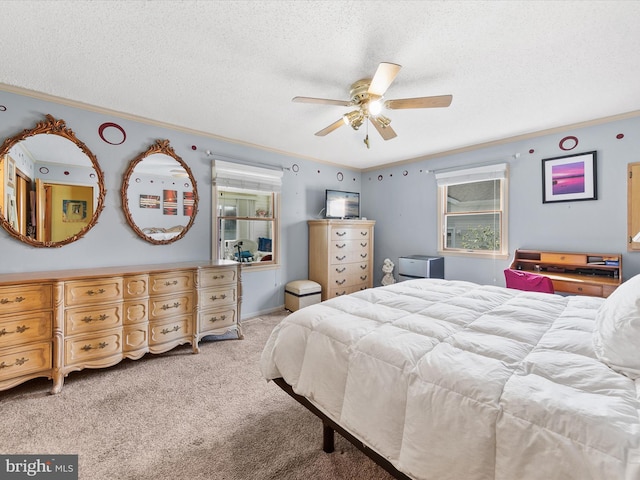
[308,220,376,300]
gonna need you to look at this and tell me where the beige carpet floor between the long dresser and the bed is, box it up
[0,312,391,480]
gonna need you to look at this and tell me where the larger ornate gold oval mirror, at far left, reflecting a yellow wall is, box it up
[0,115,106,247]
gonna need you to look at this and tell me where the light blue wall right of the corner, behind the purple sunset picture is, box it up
[362,117,640,285]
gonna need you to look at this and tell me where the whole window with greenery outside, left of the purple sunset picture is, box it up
[436,164,508,256]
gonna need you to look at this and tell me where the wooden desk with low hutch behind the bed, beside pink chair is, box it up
[510,250,622,297]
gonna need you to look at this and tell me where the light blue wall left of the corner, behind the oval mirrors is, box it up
[0,90,360,318]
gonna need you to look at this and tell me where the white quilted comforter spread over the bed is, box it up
[261,279,640,480]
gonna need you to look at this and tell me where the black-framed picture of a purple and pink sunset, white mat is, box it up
[542,151,598,203]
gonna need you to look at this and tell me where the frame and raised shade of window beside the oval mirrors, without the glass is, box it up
[211,159,283,269]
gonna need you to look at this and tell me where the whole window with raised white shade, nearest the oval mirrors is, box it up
[213,160,282,265]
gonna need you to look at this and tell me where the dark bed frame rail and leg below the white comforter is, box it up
[273,378,411,480]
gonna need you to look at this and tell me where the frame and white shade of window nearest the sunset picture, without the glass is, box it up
[436,163,509,258]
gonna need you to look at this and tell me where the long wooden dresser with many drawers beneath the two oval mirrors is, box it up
[0,260,242,393]
